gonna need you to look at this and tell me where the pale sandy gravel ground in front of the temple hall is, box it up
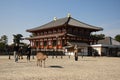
[0,56,120,80]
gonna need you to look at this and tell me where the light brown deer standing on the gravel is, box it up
[36,52,48,68]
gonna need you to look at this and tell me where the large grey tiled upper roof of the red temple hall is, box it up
[27,17,103,32]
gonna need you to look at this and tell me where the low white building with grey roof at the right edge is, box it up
[91,37,120,56]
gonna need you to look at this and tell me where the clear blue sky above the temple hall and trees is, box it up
[0,0,120,43]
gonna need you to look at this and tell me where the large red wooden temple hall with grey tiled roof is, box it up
[26,15,103,55]
